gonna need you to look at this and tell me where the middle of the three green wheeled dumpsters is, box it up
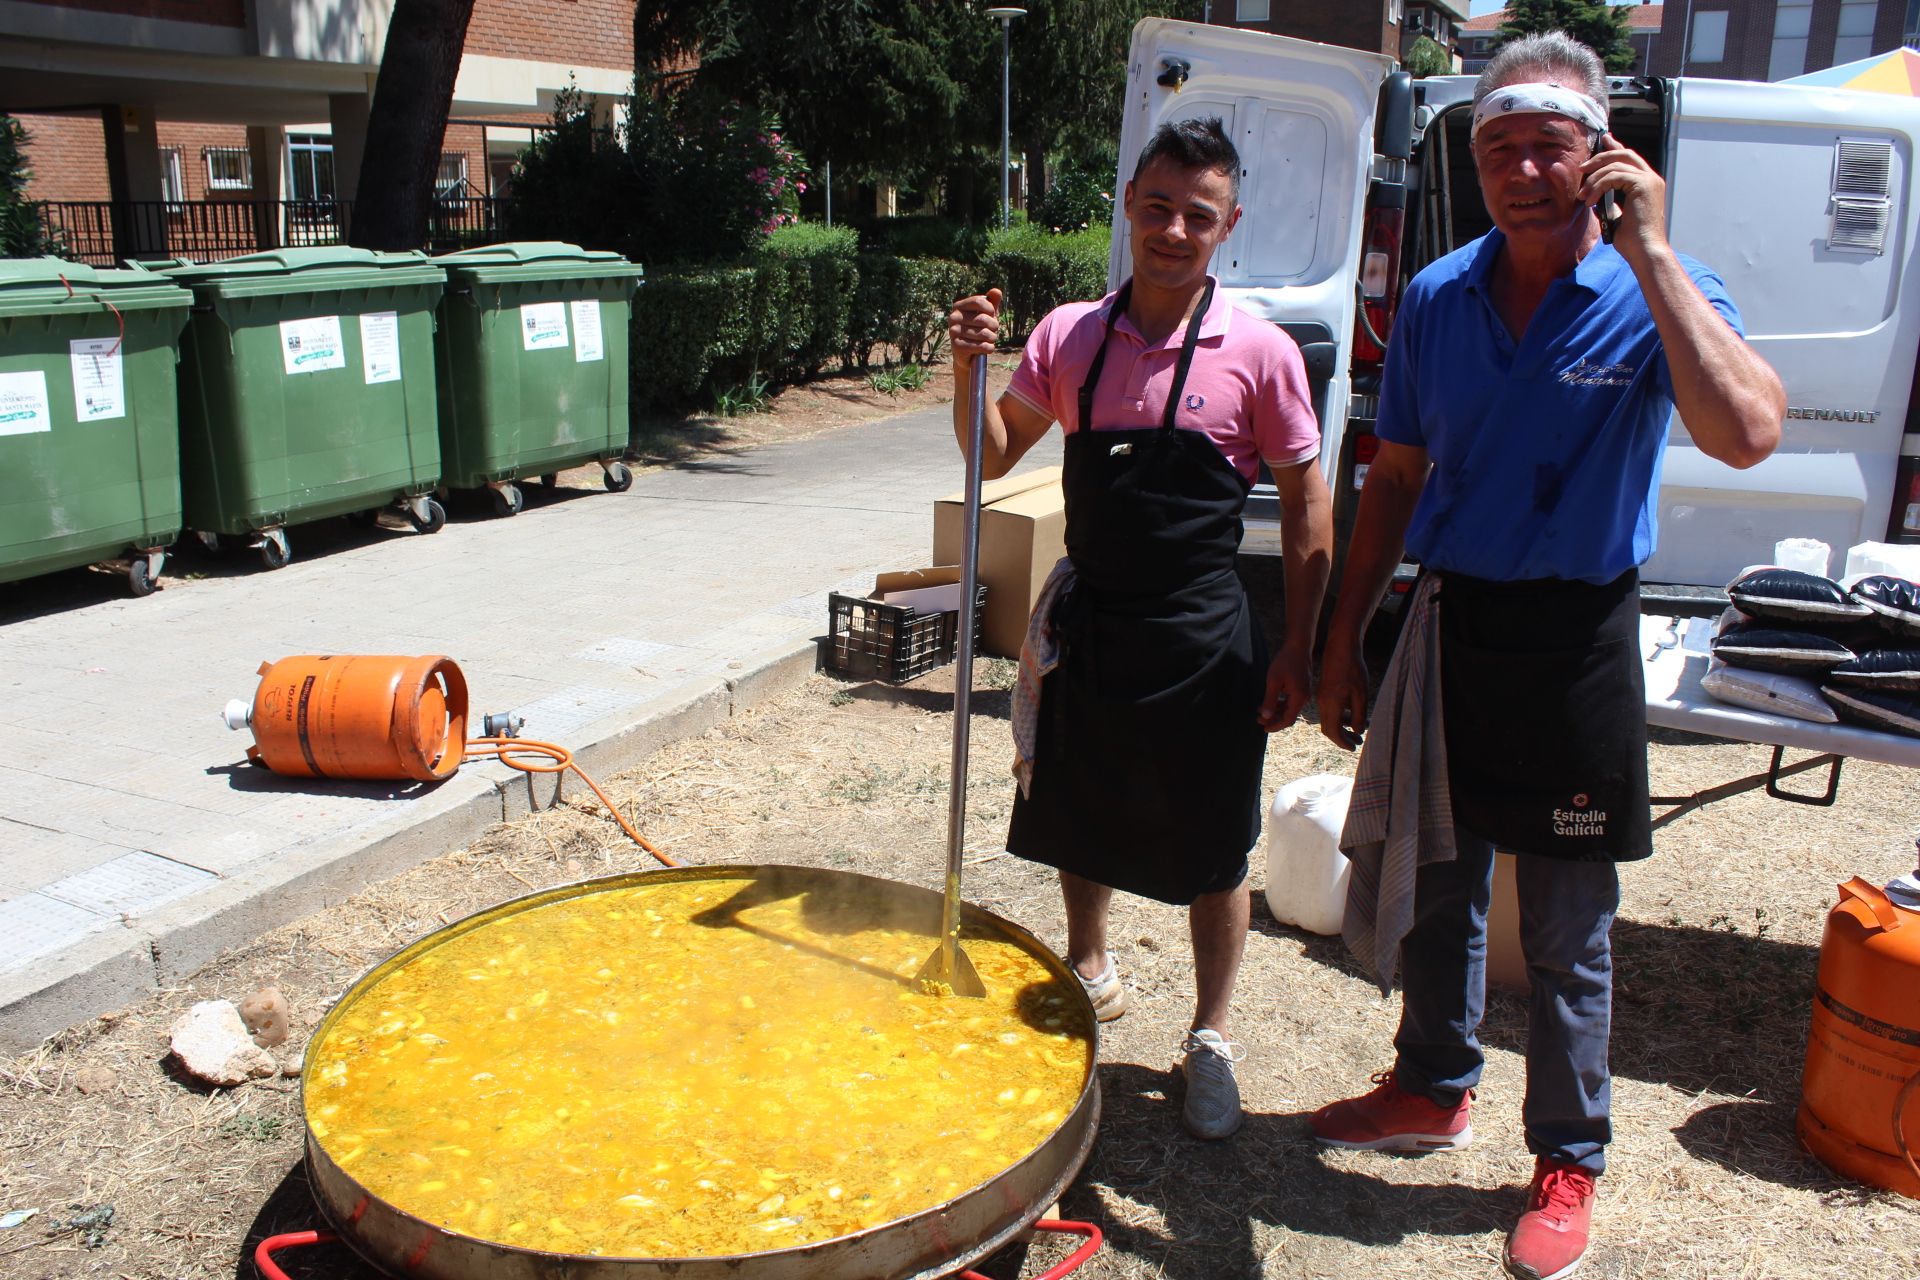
[165,246,447,568]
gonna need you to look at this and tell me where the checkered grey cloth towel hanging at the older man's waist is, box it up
[1340,574,1455,996]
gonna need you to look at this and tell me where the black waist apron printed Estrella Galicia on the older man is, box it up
[1440,570,1653,862]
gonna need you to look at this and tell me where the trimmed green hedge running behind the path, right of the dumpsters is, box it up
[632,223,1106,409]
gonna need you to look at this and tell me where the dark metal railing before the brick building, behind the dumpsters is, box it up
[36,196,507,267]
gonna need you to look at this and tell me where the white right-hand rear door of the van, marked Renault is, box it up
[1642,79,1920,585]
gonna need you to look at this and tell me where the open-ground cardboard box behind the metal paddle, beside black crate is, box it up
[933,466,1068,658]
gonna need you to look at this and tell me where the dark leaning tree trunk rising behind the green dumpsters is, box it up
[348,0,474,249]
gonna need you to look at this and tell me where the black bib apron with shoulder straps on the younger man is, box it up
[1006,282,1267,904]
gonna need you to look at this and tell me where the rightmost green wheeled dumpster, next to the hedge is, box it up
[434,242,641,516]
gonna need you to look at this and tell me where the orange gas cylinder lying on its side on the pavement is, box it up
[227,654,467,783]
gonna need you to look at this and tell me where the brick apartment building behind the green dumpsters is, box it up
[0,0,634,261]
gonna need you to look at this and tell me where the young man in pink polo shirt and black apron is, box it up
[948,119,1332,1138]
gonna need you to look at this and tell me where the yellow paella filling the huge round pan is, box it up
[305,877,1094,1257]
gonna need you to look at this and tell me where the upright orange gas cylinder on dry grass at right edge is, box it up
[1797,852,1920,1199]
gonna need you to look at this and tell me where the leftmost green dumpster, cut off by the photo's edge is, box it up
[0,257,192,595]
